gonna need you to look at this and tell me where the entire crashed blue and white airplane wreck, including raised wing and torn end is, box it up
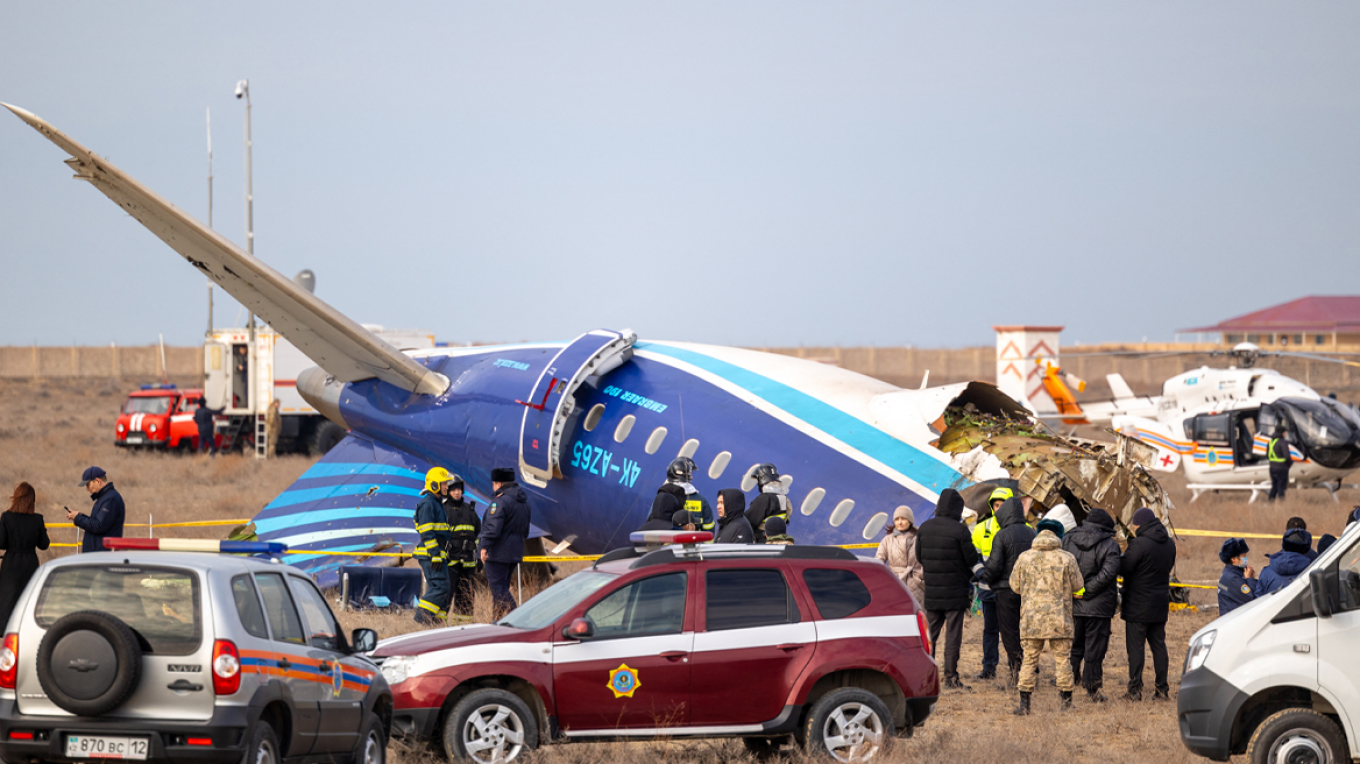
[2,107,1166,582]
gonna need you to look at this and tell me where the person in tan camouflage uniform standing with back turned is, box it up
[1010,519,1085,716]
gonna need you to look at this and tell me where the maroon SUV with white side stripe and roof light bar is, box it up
[374,533,938,764]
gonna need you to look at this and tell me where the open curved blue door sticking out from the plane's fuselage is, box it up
[518,329,638,485]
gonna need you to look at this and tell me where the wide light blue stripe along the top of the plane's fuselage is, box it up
[636,343,967,492]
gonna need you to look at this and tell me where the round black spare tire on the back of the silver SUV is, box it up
[37,610,141,716]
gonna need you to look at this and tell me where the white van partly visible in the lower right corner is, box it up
[1176,523,1360,764]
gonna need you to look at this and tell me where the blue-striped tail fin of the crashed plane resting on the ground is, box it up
[252,434,545,587]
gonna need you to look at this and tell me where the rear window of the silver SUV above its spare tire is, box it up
[34,566,203,655]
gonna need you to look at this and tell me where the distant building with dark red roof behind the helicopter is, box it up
[1180,295,1360,351]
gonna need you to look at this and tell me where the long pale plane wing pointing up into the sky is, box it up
[3,103,449,396]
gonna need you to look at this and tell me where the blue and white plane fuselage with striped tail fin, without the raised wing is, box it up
[262,333,1022,579]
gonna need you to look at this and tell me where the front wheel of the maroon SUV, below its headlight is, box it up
[443,689,539,764]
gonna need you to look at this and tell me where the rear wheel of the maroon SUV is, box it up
[800,687,895,763]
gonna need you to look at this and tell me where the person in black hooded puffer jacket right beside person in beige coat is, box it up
[917,488,982,689]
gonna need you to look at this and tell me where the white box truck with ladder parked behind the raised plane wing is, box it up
[203,325,435,457]
